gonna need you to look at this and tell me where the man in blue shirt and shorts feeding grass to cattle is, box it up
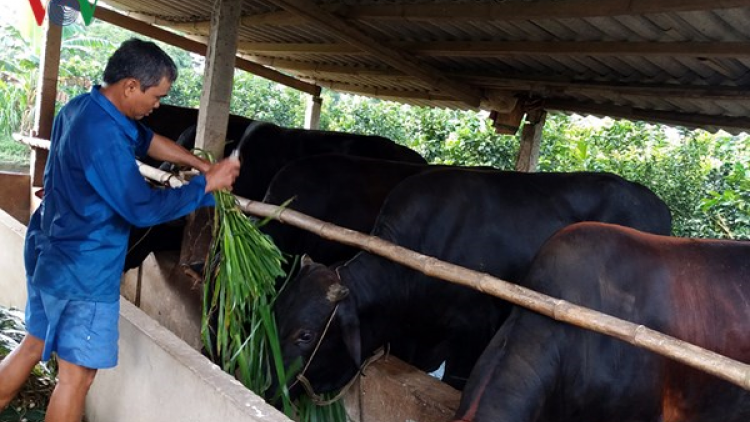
[0,39,239,422]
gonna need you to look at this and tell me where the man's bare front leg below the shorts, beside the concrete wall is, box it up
[44,356,96,422]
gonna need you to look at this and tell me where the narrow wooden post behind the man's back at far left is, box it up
[30,19,62,213]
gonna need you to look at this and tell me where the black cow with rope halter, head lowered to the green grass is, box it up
[275,169,671,394]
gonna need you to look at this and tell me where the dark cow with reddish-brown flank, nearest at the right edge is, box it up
[456,223,750,422]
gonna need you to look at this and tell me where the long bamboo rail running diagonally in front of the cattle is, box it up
[135,160,750,390]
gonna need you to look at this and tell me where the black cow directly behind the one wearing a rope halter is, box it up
[261,154,435,265]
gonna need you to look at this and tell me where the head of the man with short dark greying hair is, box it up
[103,38,177,119]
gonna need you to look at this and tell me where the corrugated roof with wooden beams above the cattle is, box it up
[100,0,750,132]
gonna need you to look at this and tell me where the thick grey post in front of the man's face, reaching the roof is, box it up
[195,0,242,159]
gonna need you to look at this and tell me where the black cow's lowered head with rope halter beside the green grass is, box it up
[268,256,361,398]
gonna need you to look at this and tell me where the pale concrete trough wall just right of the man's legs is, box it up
[86,300,290,422]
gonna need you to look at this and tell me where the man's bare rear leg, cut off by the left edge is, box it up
[0,333,44,411]
